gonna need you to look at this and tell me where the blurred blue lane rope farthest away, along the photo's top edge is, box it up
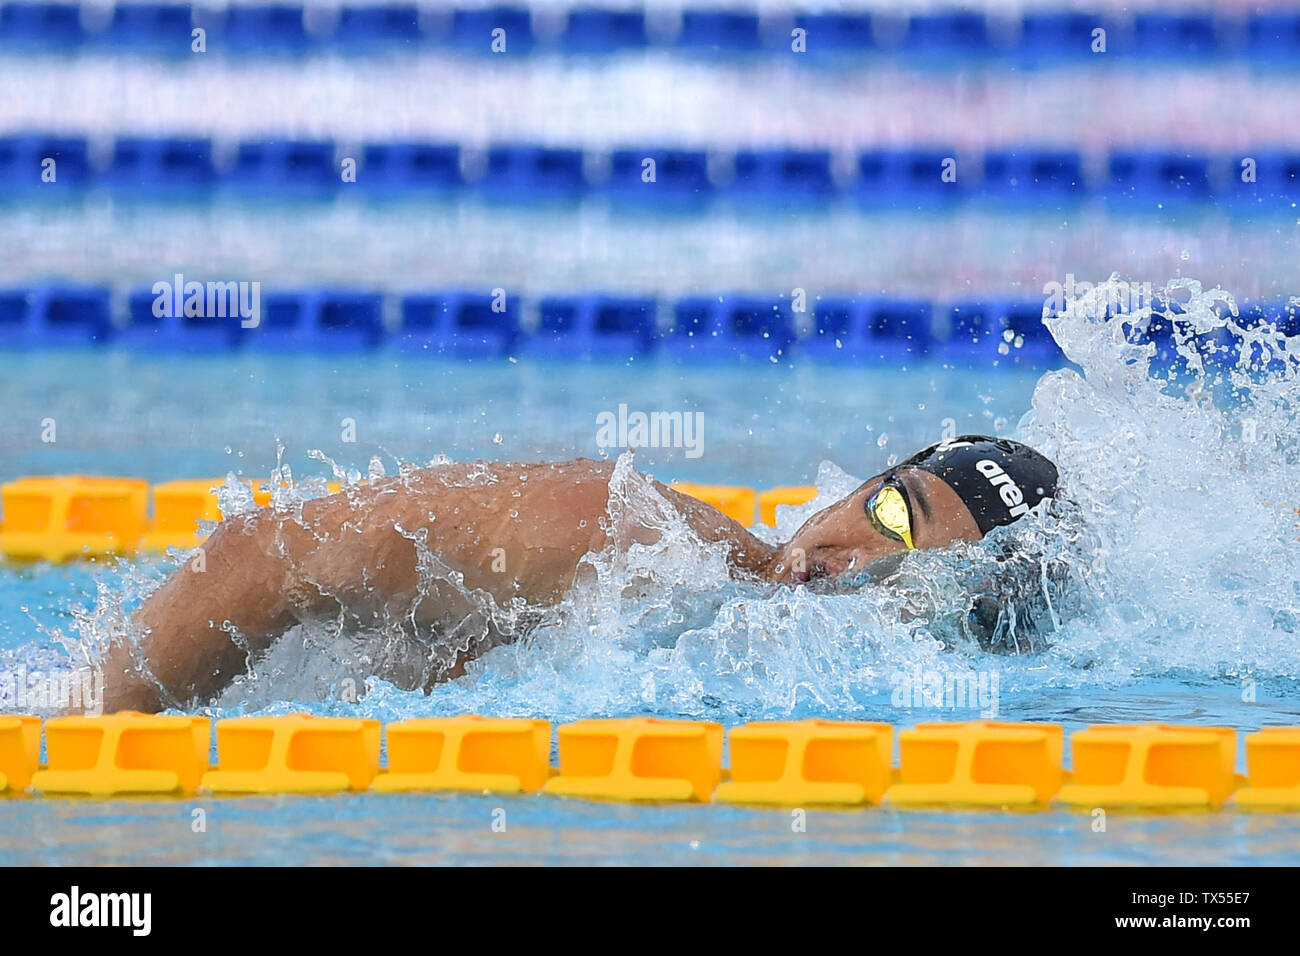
[0,1,1300,64]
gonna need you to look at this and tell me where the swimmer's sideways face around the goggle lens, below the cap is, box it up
[774,468,982,584]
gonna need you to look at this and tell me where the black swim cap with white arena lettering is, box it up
[898,434,1057,535]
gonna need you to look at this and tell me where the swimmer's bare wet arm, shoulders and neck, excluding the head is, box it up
[104,460,775,711]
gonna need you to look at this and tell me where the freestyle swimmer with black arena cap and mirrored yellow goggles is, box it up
[104,436,1057,711]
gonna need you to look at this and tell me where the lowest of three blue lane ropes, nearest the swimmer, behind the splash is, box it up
[0,284,1300,367]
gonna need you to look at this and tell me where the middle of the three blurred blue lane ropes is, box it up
[0,133,1300,203]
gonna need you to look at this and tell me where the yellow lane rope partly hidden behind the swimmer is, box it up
[0,475,816,562]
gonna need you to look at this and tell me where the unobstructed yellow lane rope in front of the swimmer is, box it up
[0,713,1300,810]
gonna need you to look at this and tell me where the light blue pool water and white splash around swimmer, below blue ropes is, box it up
[0,293,1300,865]
